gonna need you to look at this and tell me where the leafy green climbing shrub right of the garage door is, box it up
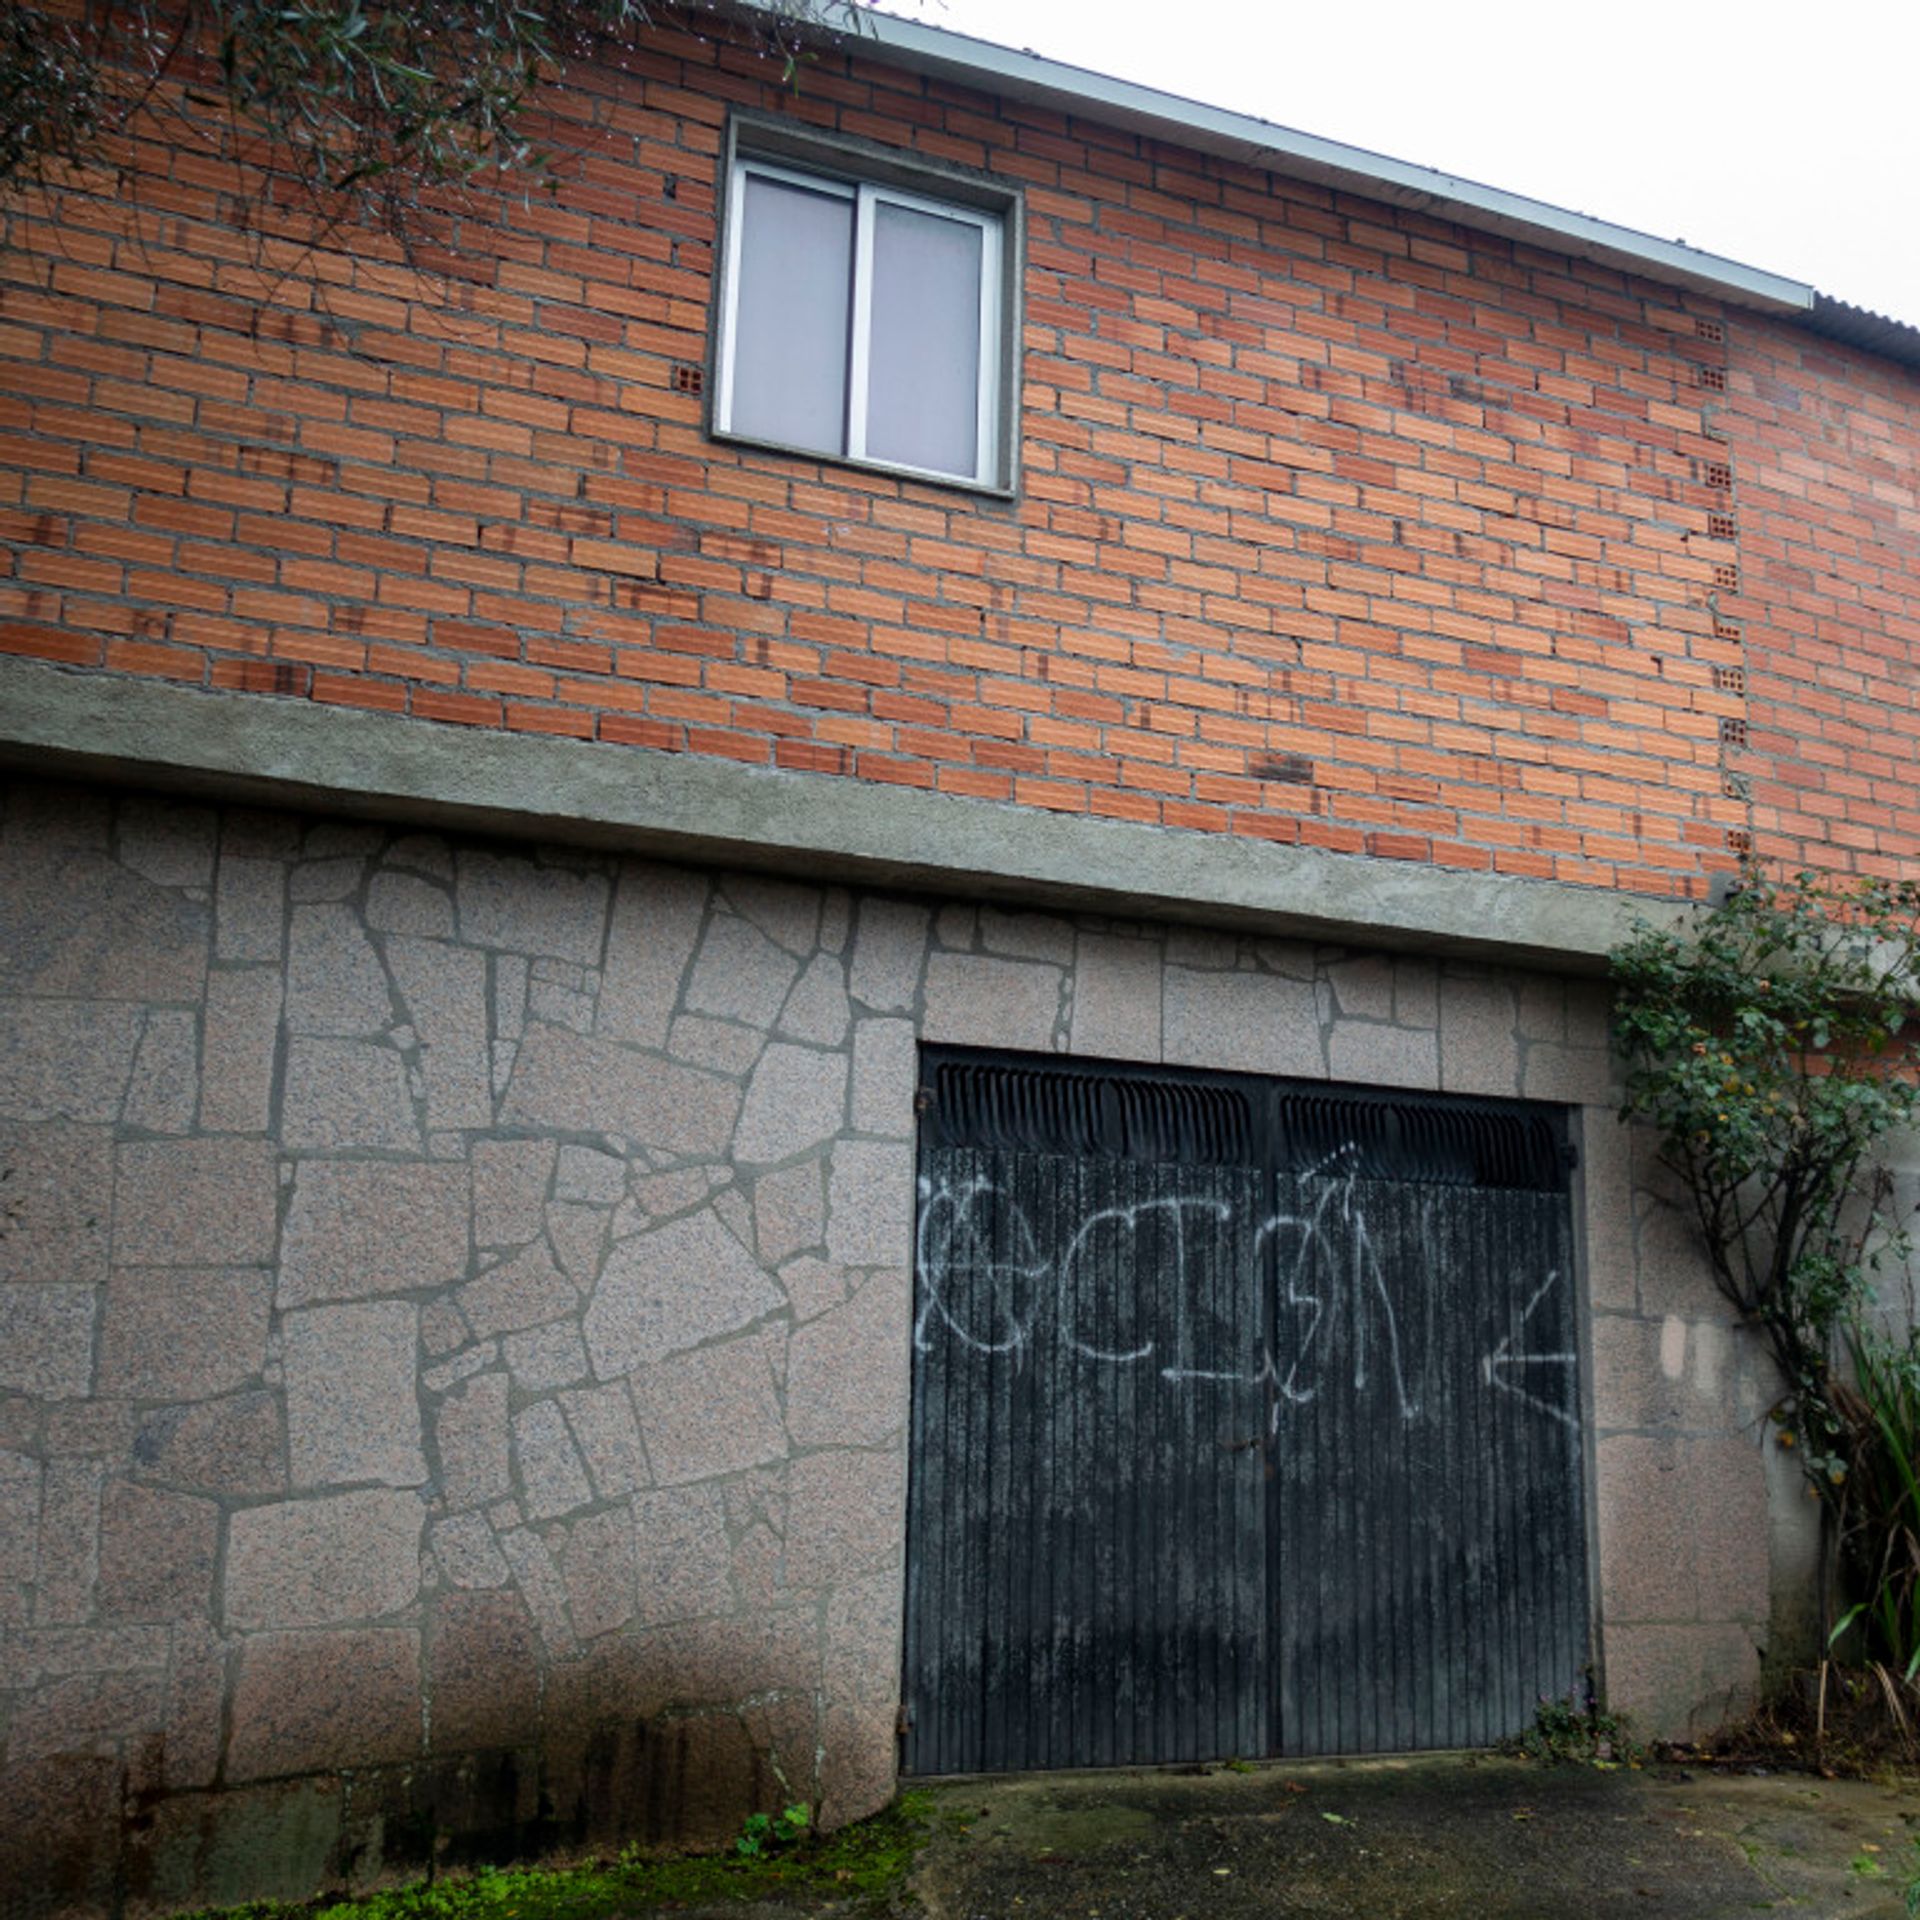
[1613,866,1920,1543]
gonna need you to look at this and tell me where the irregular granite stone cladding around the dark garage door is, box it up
[0,783,1801,1912]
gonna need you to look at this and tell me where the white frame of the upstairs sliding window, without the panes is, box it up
[712,152,1012,493]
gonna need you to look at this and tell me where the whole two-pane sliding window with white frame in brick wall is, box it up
[714,130,1012,492]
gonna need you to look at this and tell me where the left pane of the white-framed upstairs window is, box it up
[726,173,852,453]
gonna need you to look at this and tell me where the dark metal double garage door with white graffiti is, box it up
[904,1050,1588,1774]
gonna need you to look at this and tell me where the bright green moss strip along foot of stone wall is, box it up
[186,1793,933,1920]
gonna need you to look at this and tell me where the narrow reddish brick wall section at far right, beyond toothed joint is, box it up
[1724,319,1920,877]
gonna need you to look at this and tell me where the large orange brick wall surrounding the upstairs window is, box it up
[0,11,1745,893]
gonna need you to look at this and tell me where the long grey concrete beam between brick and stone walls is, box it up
[0,659,1674,973]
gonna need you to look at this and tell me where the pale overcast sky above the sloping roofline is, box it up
[887,0,1920,324]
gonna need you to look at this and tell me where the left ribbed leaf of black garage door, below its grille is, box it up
[908,1148,1271,1772]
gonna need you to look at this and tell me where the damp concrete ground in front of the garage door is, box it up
[914,1755,1920,1920]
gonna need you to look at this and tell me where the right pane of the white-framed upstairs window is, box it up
[866,200,981,478]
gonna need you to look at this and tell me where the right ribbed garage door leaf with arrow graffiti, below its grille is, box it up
[1273,1177,1588,1753]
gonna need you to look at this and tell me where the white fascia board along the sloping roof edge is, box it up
[843,8,1814,313]
